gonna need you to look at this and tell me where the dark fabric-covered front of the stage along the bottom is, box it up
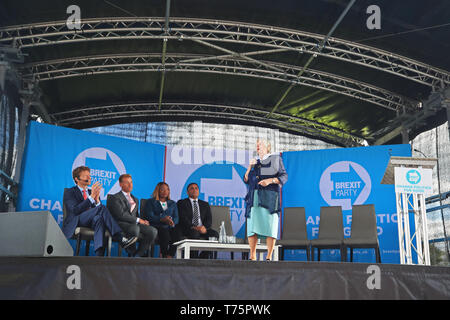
[0,257,450,300]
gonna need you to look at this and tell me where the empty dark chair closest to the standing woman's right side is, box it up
[277,207,311,261]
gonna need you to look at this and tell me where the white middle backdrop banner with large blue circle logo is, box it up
[165,146,249,238]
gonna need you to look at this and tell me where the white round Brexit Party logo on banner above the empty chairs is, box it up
[320,161,372,210]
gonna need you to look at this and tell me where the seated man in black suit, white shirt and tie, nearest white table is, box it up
[177,183,219,256]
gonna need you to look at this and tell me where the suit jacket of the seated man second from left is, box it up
[106,191,139,224]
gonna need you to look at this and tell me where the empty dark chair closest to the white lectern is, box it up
[344,204,381,263]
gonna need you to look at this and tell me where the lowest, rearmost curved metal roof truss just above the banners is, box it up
[50,102,366,147]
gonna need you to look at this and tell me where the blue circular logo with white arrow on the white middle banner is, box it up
[181,161,247,238]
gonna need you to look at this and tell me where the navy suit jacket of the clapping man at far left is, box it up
[62,186,95,238]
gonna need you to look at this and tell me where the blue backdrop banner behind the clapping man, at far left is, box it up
[17,122,165,253]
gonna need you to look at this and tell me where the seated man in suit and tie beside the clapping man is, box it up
[106,174,158,257]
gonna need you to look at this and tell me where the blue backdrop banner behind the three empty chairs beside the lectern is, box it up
[282,144,411,263]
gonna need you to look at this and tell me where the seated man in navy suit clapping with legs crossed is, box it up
[62,166,137,256]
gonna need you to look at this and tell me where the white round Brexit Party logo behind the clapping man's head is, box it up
[72,147,126,200]
